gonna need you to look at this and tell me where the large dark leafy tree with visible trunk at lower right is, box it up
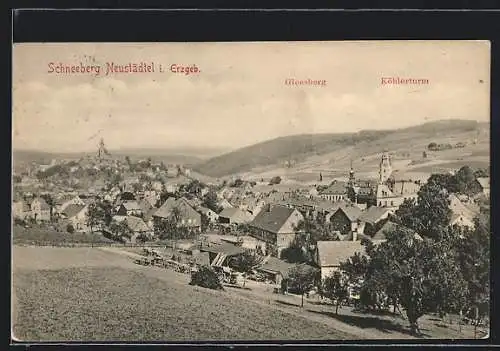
[364,227,464,334]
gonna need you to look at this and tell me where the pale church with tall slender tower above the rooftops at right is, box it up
[348,151,421,210]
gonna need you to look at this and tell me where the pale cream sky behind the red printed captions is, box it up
[12,41,490,152]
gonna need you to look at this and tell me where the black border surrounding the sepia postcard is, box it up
[4,9,500,348]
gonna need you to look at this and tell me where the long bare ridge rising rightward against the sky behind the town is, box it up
[194,119,489,177]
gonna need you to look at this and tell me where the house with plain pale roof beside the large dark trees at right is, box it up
[313,241,365,280]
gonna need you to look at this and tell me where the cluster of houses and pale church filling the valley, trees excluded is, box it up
[12,149,489,286]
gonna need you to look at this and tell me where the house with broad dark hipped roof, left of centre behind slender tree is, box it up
[153,197,201,231]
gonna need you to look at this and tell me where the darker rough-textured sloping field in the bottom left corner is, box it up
[14,267,352,341]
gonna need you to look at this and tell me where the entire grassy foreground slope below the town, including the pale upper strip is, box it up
[12,246,488,341]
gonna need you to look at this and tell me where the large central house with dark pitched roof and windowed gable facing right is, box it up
[249,205,304,257]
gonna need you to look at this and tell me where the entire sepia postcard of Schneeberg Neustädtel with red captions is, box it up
[11,41,491,343]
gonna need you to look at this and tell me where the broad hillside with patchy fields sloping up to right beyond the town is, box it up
[194,120,489,177]
